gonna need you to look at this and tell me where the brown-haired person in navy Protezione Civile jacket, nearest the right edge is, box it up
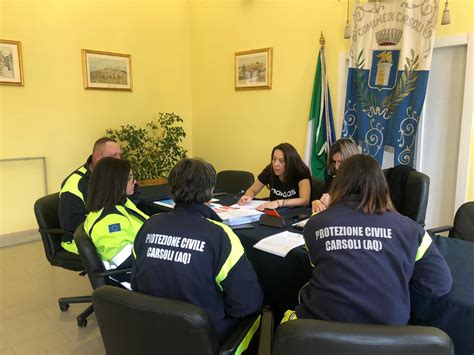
[296,154,452,325]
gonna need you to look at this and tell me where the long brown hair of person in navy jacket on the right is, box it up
[330,154,395,214]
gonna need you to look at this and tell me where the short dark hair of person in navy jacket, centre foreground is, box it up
[168,158,216,203]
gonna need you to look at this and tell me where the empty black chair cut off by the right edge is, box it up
[428,201,474,242]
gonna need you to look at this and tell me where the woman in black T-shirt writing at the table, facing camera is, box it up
[239,143,311,211]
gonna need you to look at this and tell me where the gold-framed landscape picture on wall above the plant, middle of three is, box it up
[82,49,132,91]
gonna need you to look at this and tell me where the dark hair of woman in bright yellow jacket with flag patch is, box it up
[86,157,130,212]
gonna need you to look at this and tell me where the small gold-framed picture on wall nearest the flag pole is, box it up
[235,48,272,90]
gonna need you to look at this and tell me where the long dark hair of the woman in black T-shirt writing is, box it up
[267,143,311,186]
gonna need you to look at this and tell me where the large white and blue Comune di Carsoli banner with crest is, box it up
[342,0,438,166]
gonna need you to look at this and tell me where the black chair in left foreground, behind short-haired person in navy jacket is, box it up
[92,286,260,355]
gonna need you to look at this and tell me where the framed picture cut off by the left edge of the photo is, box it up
[0,39,23,85]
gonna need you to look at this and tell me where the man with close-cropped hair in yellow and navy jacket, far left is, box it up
[58,137,121,254]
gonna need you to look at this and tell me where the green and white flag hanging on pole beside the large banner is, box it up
[305,41,336,181]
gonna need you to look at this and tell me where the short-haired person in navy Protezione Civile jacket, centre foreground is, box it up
[131,159,263,340]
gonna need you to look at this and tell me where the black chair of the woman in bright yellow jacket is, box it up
[74,224,131,327]
